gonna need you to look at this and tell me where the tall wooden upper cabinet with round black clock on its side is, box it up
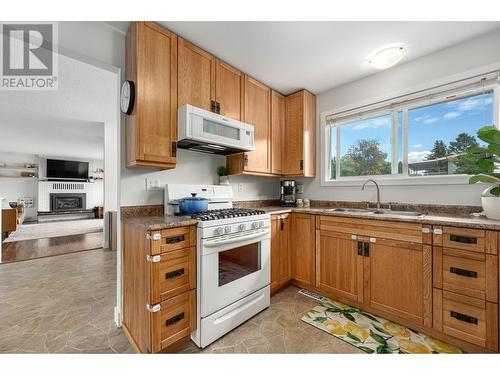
[125,22,177,169]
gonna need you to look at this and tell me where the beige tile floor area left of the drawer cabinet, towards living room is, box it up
[0,249,133,353]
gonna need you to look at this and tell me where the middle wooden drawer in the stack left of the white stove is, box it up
[151,247,196,303]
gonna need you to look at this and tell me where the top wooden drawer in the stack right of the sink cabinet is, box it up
[434,227,485,253]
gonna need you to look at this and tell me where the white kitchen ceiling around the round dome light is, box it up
[108,21,500,94]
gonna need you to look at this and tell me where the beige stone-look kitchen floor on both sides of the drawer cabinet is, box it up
[0,249,362,353]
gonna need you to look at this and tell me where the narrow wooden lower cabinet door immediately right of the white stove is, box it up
[271,214,292,293]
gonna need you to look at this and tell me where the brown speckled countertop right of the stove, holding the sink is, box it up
[259,206,500,231]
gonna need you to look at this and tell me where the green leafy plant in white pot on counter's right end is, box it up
[467,126,500,220]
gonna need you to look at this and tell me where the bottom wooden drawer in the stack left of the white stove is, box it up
[151,290,196,353]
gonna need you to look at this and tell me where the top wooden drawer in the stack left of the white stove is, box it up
[150,226,196,255]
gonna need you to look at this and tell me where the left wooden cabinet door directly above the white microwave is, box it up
[177,38,215,111]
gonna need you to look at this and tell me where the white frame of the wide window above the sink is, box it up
[320,78,500,186]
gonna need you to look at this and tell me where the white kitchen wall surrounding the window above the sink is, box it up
[303,30,500,205]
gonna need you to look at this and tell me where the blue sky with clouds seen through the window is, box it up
[332,93,493,162]
